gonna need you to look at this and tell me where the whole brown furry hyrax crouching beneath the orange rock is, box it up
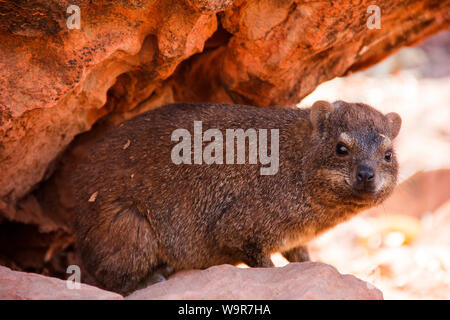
[69,101,401,293]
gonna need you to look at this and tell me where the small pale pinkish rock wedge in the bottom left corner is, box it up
[0,266,123,300]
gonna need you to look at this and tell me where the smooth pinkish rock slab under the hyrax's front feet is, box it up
[127,262,383,300]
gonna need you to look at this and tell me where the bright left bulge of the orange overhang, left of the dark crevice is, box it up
[0,0,221,218]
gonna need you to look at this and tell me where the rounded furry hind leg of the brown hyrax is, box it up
[77,196,165,294]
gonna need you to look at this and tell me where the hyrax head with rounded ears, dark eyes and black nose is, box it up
[310,101,401,205]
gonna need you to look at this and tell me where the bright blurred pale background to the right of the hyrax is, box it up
[273,31,450,299]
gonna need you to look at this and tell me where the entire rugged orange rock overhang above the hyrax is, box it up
[0,0,450,219]
